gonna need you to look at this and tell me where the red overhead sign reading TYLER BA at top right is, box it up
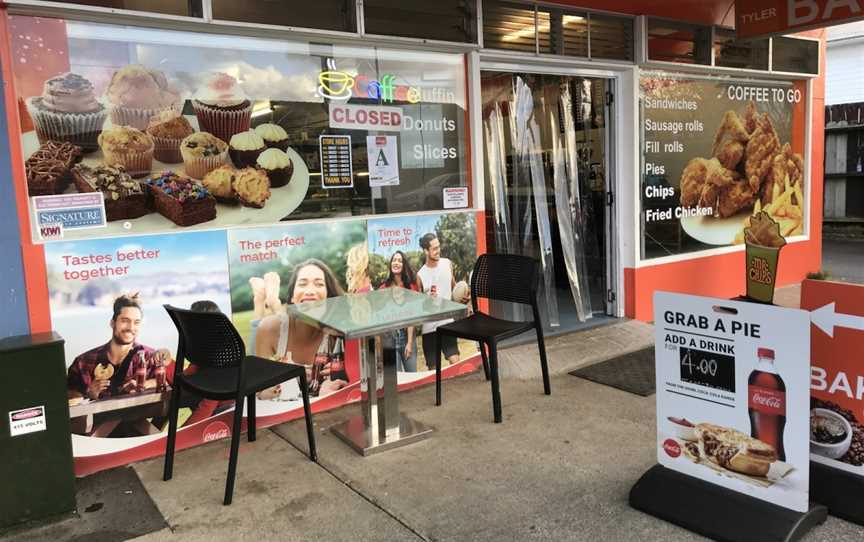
[735,0,864,39]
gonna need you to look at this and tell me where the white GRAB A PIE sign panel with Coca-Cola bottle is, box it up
[654,292,810,512]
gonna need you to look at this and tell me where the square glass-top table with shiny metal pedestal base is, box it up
[287,288,466,455]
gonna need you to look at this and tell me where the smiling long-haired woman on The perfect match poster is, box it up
[252,259,348,399]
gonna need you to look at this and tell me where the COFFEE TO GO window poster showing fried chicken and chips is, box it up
[640,72,807,258]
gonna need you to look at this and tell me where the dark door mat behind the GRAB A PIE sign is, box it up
[570,346,655,397]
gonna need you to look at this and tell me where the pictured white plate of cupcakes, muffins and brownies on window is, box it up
[15,58,309,242]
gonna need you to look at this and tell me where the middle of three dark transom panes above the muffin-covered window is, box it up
[213,0,357,32]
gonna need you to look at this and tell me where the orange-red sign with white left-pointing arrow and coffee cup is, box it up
[801,280,864,476]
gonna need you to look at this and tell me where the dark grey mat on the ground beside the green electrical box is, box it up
[0,467,168,542]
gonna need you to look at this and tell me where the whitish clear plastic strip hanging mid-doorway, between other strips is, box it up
[512,77,561,327]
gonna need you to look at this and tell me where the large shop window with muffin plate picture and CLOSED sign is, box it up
[10,16,470,242]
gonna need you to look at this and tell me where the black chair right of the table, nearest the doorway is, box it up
[435,254,552,423]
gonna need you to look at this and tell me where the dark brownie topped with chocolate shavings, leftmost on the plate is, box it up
[24,141,84,196]
